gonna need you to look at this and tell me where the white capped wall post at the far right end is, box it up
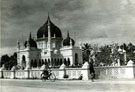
[125,60,134,79]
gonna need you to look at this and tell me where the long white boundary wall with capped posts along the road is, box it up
[0,61,135,80]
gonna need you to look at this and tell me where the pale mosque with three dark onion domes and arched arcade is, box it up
[17,14,83,69]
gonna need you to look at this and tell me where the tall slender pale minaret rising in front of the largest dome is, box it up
[47,13,51,51]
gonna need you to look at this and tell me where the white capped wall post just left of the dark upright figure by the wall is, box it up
[82,62,90,80]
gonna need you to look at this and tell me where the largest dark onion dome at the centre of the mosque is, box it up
[37,15,62,38]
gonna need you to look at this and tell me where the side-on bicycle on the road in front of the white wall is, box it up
[40,70,56,82]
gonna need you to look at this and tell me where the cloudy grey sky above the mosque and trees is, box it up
[0,0,135,55]
